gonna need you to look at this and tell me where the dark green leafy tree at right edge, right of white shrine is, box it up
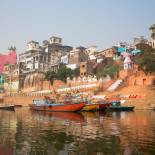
[134,44,155,74]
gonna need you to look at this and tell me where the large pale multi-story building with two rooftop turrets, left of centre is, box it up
[19,37,72,91]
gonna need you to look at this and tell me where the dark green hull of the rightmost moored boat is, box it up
[107,106,134,111]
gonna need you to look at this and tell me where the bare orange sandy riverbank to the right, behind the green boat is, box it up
[100,86,155,109]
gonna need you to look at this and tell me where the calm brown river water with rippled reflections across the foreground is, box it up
[0,108,155,155]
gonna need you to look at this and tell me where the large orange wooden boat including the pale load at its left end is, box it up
[29,100,85,112]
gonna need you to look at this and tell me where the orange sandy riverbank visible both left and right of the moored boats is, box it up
[0,86,155,109]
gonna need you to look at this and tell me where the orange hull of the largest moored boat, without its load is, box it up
[29,103,85,112]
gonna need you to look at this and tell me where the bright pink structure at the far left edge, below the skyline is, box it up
[0,51,17,73]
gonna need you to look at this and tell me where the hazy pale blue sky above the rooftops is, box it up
[0,0,155,53]
